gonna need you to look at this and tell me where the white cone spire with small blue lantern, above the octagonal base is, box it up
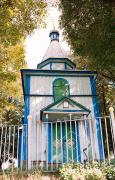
[42,27,67,61]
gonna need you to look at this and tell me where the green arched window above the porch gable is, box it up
[53,78,70,101]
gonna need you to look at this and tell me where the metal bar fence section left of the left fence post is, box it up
[0,125,27,171]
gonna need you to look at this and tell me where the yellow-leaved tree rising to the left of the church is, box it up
[0,0,47,122]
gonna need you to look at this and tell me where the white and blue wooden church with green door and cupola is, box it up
[21,30,103,169]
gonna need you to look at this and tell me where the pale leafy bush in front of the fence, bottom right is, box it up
[60,163,115,180]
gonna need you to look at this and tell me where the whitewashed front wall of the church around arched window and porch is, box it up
[28,76,98,166]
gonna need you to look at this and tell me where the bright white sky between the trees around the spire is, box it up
[25,7,69,69]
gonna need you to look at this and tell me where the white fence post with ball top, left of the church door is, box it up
[26,114,32,169]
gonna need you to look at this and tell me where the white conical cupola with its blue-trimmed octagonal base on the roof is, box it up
[37,29,76,70]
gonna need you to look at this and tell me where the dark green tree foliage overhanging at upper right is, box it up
[60,0,115,81]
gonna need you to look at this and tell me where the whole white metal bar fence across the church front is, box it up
[0,117,115,171]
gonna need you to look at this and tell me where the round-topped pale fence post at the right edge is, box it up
[109,107,115,156]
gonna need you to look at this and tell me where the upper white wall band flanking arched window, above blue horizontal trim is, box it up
[30,76,91,95]
